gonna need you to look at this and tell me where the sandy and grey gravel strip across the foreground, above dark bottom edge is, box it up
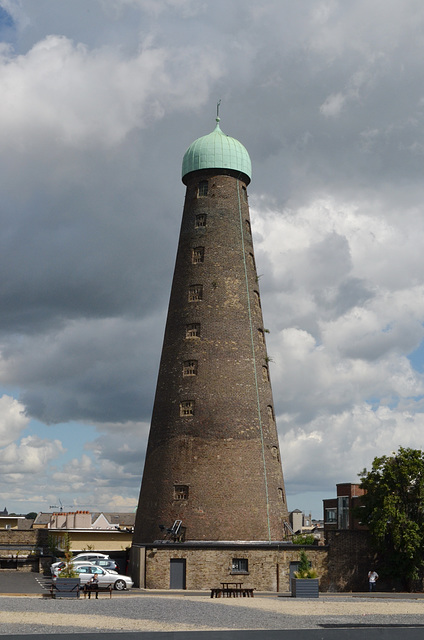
[0,594,424,635]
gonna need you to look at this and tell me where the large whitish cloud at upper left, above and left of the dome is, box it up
[0,35,225,151]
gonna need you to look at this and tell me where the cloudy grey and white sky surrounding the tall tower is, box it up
[0,0,424,517]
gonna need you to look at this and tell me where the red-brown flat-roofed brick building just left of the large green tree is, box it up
[323,482,367,533]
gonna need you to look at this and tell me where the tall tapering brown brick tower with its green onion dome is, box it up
[134,118,288,544]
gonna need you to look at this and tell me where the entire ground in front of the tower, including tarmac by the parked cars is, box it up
[0,571,424,640]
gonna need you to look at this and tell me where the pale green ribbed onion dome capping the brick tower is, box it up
[182,118,252,182]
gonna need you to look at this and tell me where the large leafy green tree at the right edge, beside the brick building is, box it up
[356,447,424,591]
